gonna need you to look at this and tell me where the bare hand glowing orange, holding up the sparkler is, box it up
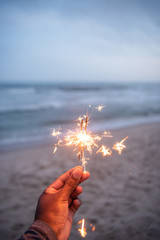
[35,166,89,240]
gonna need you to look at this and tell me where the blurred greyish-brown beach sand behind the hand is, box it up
[0,123,160,240]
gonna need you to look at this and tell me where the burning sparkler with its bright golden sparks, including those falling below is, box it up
[51,105,128,238]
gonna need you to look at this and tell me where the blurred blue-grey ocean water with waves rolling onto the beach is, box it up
[0,83,160,149]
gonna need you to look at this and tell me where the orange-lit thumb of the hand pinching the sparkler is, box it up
[61,167,82,199]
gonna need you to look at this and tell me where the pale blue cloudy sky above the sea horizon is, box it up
[0,0,160,83]
